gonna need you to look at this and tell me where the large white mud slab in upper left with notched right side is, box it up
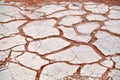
[23,19,59,38]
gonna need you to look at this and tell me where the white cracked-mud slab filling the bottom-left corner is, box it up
[0,63,36,80]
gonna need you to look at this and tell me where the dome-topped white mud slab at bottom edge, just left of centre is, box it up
[40,63,78,80]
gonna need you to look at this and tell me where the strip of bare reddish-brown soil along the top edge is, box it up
[5,0,120,6]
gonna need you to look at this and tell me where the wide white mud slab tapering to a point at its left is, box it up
[47,45,101,64]
